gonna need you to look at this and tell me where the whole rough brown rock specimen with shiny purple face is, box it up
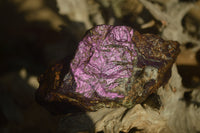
[36,25,180,111]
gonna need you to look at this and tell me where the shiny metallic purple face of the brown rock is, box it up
[70,25,137,99]
